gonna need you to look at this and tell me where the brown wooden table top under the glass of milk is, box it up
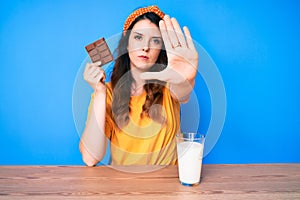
[0,164,300,200]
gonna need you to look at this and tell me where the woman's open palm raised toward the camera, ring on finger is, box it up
[142,15,198,84]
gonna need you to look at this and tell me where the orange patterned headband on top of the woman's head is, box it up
[123,5,165,33]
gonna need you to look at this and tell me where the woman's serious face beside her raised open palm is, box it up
[127,19,163,71]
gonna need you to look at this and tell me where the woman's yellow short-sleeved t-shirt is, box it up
[88,83,180,165]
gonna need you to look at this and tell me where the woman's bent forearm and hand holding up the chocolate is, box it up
[79,64,107,166]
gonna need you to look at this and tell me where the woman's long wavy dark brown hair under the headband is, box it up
[111,12,168,128]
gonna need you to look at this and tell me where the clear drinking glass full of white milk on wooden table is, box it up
[176,132,205,186]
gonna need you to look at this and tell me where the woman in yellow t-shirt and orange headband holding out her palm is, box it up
[80,6,198,166]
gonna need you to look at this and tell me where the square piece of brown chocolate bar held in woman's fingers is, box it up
[85,38,114,67]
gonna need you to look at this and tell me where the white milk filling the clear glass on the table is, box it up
[177,142,203,184]
